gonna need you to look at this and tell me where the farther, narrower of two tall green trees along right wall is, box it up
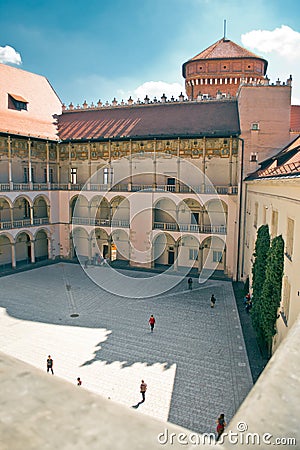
[251,225,270,341]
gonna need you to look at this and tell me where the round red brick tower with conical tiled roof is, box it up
[182,37,268,100]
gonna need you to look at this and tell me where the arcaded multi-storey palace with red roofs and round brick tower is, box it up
[0,34,300,352]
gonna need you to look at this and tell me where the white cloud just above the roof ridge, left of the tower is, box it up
[131,81,185,101]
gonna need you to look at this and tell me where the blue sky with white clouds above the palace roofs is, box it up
[0,0,300,105]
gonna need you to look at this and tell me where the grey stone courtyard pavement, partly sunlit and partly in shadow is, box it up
[0,263,252,432]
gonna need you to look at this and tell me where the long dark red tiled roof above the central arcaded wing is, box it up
[58,101,240,140]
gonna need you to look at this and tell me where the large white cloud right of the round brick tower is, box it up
[241,25,300,60]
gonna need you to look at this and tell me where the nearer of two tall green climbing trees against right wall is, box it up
[260,235,284,355]
